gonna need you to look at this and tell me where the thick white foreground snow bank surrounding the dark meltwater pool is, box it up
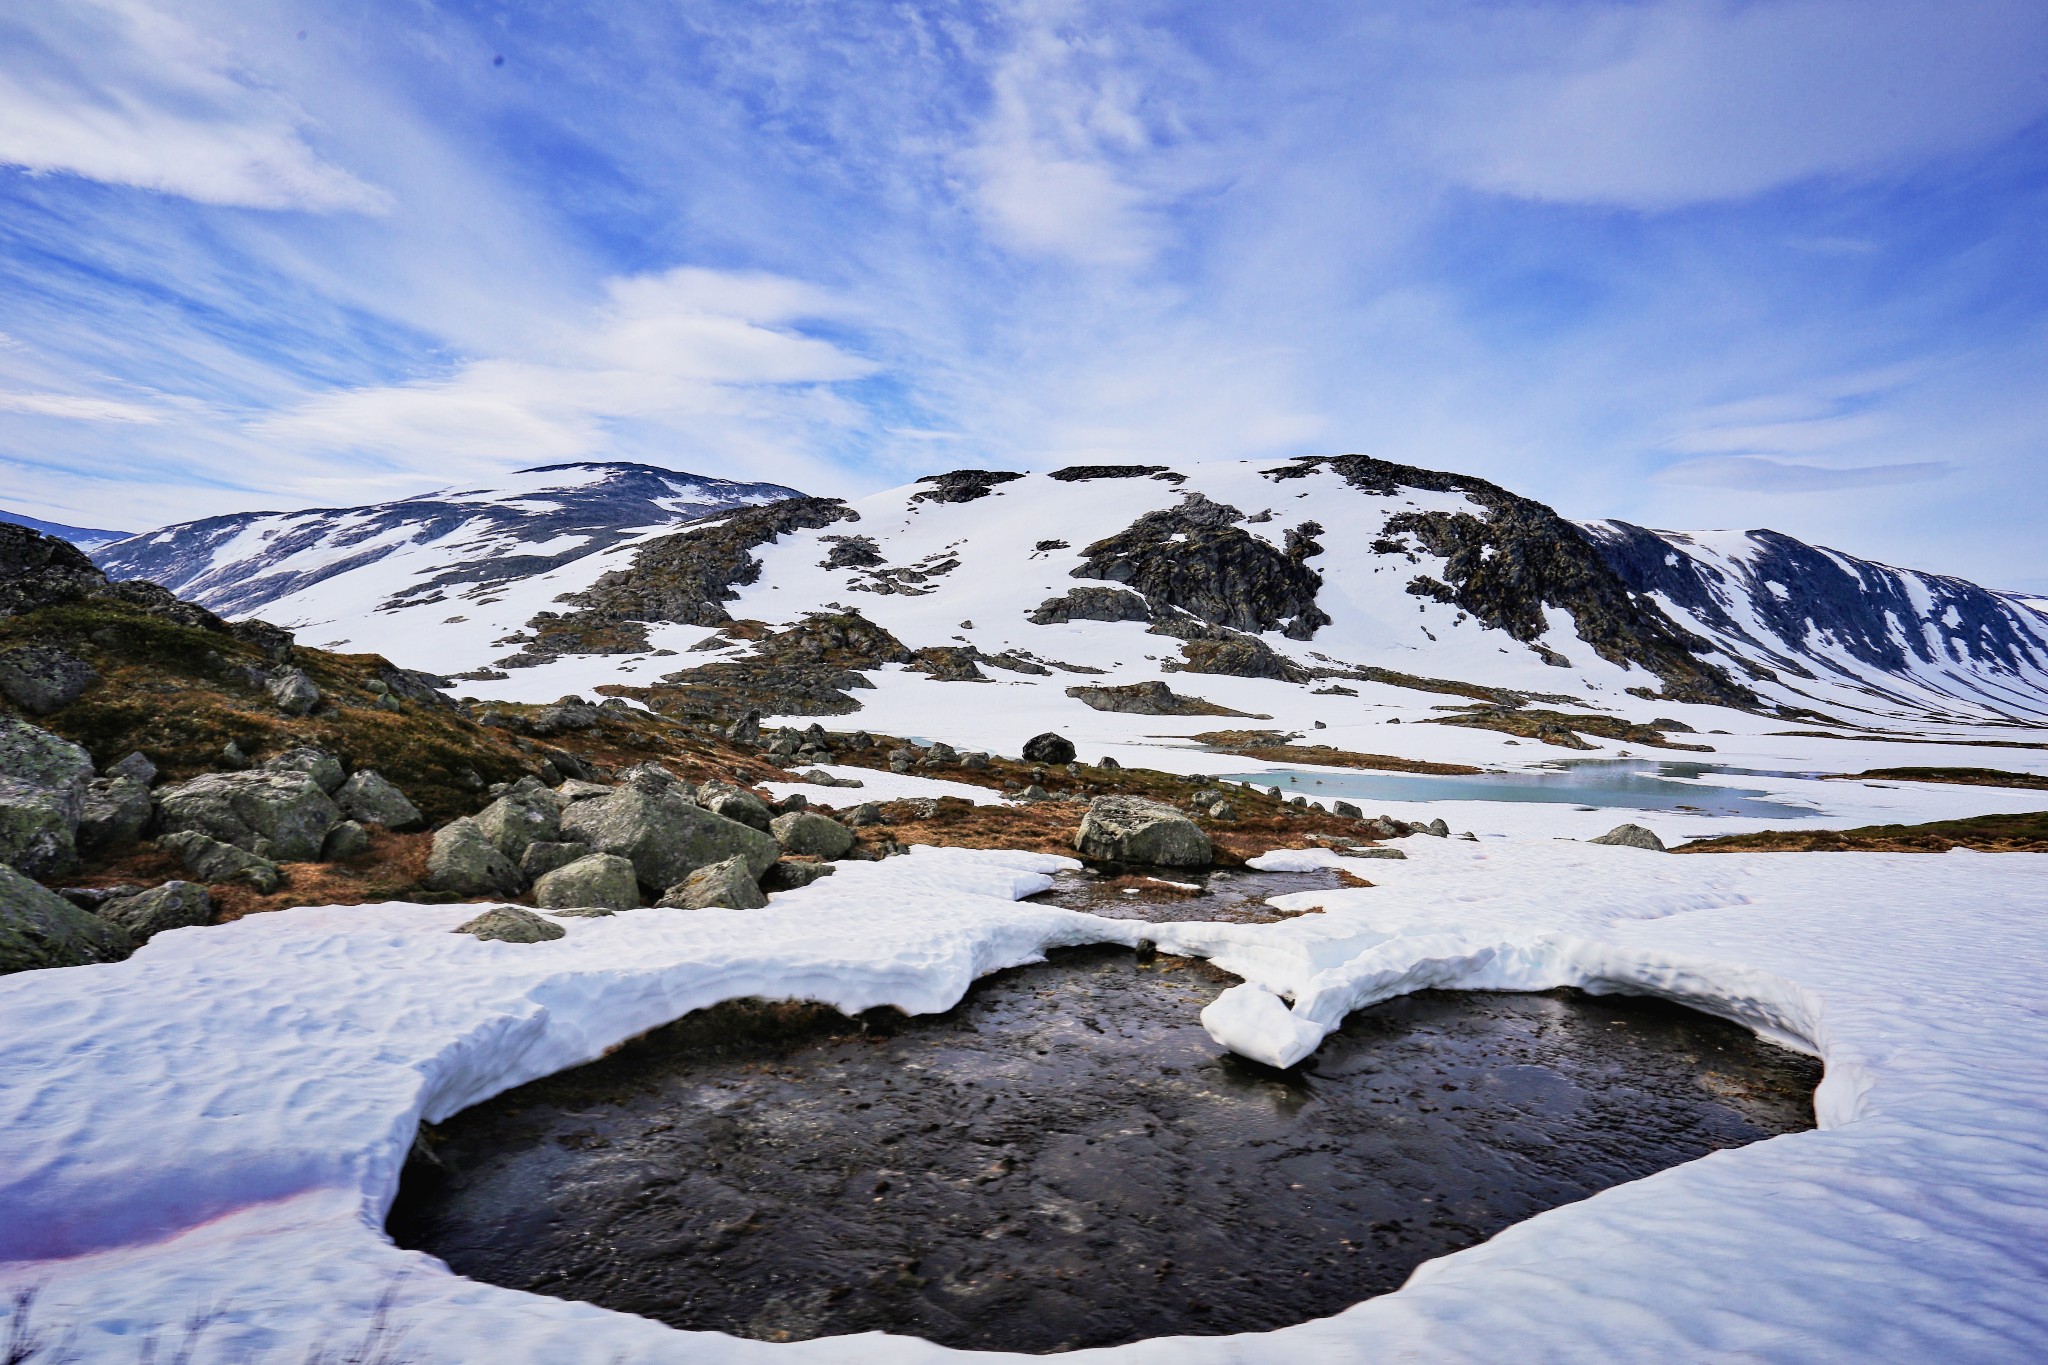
[0,839,2048,1365]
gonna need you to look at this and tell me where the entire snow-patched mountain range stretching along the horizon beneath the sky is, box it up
[83,456,2048,729]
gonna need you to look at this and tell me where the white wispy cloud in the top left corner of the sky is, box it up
[0,0,389,213]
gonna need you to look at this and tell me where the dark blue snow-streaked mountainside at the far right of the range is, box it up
[1585,522,2048,722]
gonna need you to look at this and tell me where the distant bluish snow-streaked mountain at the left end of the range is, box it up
[92,463,797,659]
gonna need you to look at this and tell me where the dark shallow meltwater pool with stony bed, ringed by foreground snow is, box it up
[389,874,1821,1351]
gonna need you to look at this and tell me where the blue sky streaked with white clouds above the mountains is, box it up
[0,0,2048,591]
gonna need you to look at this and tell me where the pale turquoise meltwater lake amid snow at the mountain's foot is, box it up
[1221,759,1812,821]
